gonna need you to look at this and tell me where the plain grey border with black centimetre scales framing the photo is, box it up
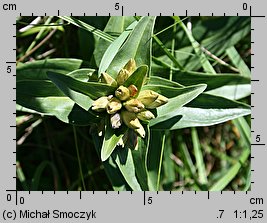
[0,0,267,222]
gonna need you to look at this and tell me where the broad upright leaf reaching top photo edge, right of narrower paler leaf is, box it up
[107,16,155,78]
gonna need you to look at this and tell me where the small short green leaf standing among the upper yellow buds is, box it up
[123,65,148,91]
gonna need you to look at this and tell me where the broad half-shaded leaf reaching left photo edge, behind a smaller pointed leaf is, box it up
[16,59,97,125]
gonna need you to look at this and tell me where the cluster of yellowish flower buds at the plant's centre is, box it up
[92,59,168,138]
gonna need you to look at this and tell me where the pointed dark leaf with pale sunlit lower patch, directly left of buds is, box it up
[47,72,116,110]
